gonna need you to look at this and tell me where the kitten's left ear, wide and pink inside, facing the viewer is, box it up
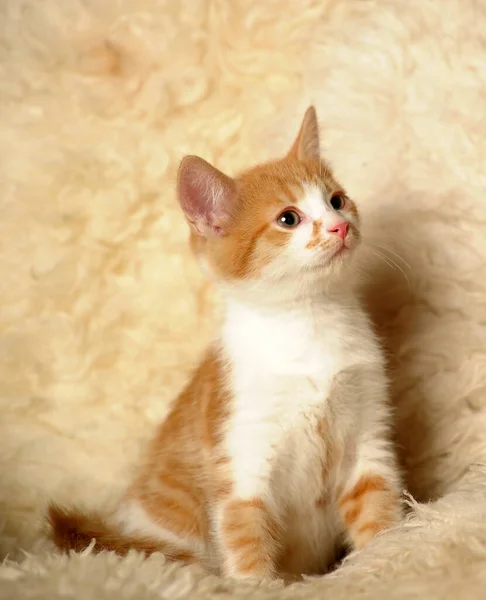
[177,156,236,237]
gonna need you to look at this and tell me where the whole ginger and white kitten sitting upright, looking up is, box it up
[49,107,401,578]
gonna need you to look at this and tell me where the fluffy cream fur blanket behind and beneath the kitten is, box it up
[0,0,486,600]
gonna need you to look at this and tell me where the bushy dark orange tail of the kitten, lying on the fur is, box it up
[48,504,196,563]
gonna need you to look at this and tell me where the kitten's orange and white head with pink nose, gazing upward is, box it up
[178,107,359,296]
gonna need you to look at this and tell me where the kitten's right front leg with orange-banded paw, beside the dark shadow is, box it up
[338,440,403,549]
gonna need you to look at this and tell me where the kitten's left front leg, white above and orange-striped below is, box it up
[216,426,282,579]
